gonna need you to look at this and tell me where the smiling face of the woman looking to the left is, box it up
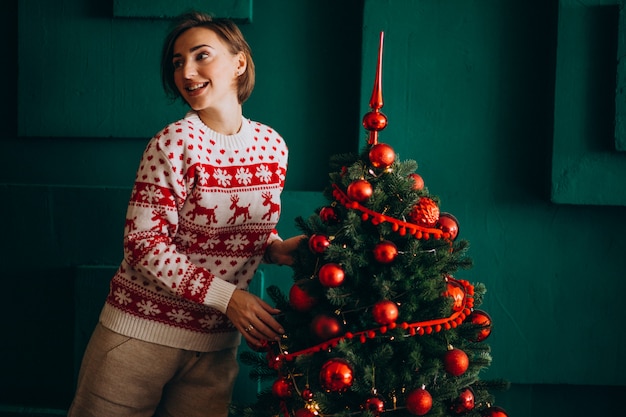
[172,27,246,111]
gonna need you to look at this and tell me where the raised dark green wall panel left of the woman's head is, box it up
[17,0,184,138]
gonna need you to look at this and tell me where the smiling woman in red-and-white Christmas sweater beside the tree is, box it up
[69,12,301,417]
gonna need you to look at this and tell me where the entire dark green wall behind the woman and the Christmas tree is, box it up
[0,0,626,417]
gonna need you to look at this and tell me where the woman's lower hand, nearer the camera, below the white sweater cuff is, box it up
[226,290,285,346]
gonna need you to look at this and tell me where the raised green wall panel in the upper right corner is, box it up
[551,0,626,205]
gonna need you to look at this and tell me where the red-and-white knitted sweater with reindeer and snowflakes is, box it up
[100,112,288,351]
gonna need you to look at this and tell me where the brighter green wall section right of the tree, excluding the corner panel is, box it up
[361,0,626,385]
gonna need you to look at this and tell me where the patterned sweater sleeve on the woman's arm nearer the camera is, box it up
[124,126,236,313]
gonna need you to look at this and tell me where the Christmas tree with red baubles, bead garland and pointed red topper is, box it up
[235,33,507,417]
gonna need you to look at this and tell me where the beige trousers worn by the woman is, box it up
[68,324,239,417]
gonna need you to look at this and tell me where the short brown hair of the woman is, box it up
[161,11,255,104]
